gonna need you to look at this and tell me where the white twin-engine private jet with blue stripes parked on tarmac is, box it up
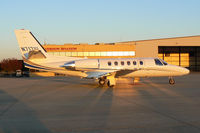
[15,29,190,87]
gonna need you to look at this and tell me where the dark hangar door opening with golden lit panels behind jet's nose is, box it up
[158,46,200,71]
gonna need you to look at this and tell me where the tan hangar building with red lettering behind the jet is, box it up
[44,36,200,71]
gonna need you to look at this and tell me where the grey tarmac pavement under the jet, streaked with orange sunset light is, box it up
[0,73,200,133]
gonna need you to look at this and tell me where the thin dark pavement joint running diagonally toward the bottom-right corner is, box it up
[105,87,200,130]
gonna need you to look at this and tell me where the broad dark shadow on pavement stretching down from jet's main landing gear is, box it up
[68,87,113,133]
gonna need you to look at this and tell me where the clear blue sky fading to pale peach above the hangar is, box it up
[0,0,200,60]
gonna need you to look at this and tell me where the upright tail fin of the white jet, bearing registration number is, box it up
[15,30,47,59]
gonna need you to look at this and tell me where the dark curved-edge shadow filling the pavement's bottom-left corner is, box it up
[0,91,50,133]
